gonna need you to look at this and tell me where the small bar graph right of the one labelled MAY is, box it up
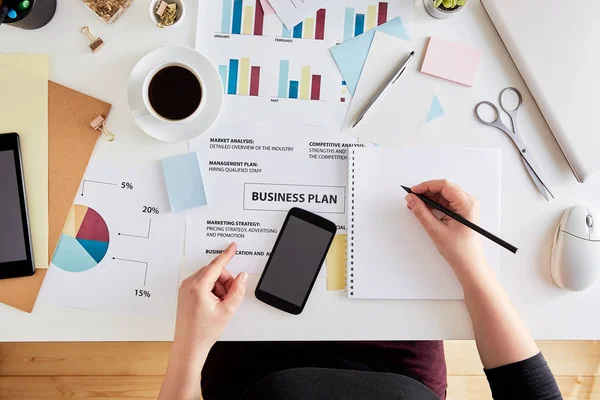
[277,60,321,100]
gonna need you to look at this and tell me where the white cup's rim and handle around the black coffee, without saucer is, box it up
[131,61,206,124]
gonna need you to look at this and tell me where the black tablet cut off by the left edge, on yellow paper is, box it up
[0,133,35,279]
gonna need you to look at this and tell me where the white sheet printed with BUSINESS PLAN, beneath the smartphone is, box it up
[182,122,364,277]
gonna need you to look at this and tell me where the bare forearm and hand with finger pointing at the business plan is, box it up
[158,243,248,400]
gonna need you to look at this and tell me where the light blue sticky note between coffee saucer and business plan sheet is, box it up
[161,153,207,211]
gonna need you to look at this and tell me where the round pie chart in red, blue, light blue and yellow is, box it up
[52,204,110,272]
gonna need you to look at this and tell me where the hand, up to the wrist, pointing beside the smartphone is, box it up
[173,243,248,364]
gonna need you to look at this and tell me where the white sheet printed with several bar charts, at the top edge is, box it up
[196,0,413,128]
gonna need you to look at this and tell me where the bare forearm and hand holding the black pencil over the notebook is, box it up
[406,180,539,369]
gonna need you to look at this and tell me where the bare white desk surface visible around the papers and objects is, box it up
[0,0,600,341]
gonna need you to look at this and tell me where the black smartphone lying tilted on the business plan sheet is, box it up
[255,208,336,315]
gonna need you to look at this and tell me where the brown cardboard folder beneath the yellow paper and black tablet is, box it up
[0,81,111,312]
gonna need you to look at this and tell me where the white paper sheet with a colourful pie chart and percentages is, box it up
[40,160,185,319]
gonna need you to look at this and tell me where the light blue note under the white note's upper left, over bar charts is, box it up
[331,17,410,94]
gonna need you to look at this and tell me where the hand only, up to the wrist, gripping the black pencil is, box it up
[406,180,486,272]
